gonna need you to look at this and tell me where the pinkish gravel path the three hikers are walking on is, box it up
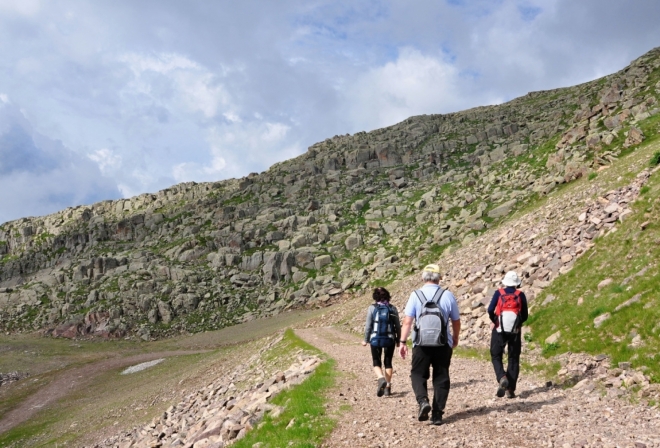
[297,328,660,448]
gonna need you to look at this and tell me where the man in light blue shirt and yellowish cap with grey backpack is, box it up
[399,264,461,425]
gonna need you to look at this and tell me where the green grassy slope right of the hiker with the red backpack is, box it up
[528,145,660,381]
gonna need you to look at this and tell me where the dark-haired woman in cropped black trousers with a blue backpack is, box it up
[362,288,401,397]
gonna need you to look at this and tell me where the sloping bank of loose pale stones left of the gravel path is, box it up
[89,336,321,448]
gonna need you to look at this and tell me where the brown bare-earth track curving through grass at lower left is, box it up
[0,350,202,434]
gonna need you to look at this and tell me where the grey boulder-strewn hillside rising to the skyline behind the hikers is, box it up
[0,49,660,339]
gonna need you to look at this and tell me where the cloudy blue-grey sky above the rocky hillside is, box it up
[0,0,660,223]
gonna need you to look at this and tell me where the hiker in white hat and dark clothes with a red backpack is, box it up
[488,271,528,398]
